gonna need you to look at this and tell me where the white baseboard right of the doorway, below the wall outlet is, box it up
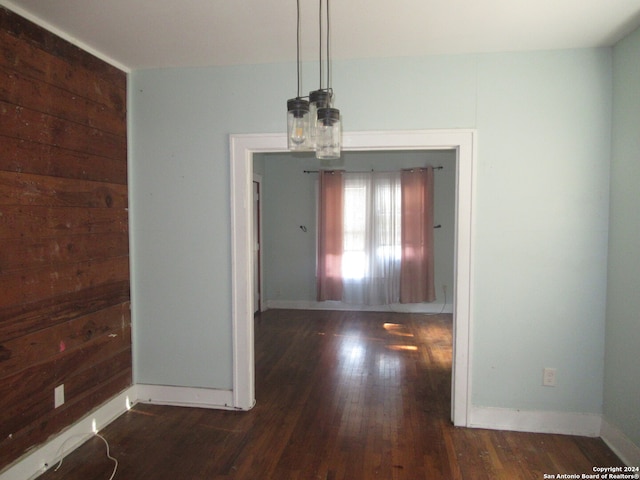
[469,407,602,437]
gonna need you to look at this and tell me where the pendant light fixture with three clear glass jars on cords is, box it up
[287,0,342,159]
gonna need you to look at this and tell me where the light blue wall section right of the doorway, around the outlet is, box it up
[472,51,611,413]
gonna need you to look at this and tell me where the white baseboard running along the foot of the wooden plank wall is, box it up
[0,386,136,480]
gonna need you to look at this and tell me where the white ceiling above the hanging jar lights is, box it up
[0,0,640,69]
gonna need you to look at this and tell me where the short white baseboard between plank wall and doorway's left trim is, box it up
[136,384,237,410]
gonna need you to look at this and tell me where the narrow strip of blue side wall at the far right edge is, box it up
[604,25,640,448]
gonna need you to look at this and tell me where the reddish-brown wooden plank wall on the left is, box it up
[0,7,132,470]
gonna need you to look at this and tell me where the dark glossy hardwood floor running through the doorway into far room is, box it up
[33,310,623,480]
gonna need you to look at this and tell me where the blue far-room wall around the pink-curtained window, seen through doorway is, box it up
[254,150,456,308]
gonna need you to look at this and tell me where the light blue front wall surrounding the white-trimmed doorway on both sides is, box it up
[131,49,612,413]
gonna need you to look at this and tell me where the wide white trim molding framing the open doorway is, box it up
[229,129,477,426]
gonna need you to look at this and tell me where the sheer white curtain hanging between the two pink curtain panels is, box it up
[342,172,402,305]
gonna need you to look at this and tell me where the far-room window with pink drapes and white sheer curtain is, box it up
[317,168,435,305]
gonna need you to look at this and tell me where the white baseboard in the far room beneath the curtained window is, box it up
[264,300,453,313]
